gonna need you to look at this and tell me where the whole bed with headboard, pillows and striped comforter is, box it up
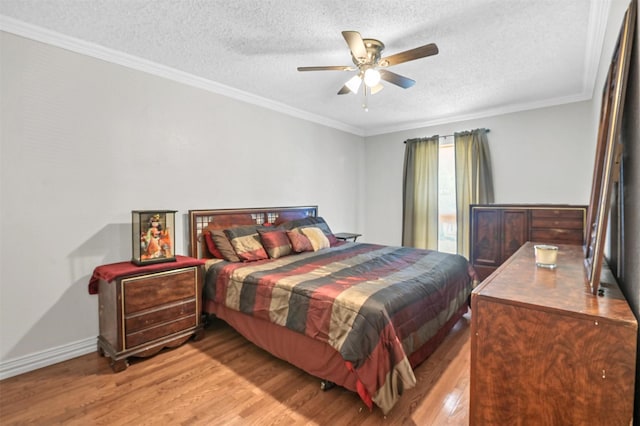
[189,206,474,414]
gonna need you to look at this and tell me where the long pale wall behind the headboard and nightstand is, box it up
[0,32,364,377]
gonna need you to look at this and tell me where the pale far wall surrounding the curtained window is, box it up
[364,102,595,245]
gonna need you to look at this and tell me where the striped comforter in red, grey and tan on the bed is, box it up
[204,243,472,413]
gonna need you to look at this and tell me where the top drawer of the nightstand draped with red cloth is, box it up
[122,267,197,315]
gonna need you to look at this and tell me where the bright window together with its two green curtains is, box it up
[402,129,493,256]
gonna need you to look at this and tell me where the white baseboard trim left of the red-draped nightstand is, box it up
[0,337,97,380]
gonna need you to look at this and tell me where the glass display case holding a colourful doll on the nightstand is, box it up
[131,210,177,266]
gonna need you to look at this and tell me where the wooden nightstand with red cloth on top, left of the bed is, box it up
[90,256,204,372]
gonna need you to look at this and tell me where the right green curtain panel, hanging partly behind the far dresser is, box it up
[454,129,493,259]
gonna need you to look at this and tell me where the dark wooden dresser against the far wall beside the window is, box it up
[469,204,587,280]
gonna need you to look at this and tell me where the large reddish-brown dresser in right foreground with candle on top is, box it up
[469,243,638,426]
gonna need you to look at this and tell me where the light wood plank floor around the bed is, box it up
[0,314,470,425]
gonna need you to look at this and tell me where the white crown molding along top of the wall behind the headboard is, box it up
[0,15,364,136]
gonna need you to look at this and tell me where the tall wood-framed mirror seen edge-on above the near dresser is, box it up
[584,1,637,294]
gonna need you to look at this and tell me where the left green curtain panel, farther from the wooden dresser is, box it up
[402,135,440,250]
